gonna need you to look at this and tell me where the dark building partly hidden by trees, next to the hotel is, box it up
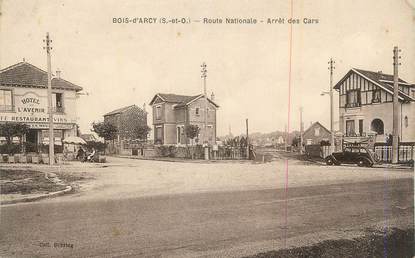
[104,105,147,153]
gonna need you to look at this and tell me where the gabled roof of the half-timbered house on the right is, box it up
[333,68,415,101]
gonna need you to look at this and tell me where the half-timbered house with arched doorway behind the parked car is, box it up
[334,68,415,142]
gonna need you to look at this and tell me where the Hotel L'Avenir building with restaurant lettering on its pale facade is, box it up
[0,61,82,152]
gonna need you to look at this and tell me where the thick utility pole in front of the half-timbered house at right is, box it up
[392,46,401,163]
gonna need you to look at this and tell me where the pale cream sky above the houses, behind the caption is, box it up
[0,0,415,136]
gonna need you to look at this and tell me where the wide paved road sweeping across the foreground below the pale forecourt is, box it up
[0,158,413,257]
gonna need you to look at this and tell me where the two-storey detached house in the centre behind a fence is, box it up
[150,93,219,145]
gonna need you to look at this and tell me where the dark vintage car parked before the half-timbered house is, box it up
[325,147,378,167]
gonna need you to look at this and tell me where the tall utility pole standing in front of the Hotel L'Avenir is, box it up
[43,32,55,166]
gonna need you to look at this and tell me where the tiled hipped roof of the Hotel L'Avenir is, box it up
[0,62,82,91]
